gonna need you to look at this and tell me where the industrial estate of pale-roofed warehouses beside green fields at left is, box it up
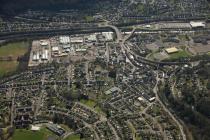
[28,32,107,67]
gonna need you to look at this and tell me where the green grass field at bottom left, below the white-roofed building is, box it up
[11,128,53,140]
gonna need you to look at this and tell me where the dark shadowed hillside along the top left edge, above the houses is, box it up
[0,0,119,15]
